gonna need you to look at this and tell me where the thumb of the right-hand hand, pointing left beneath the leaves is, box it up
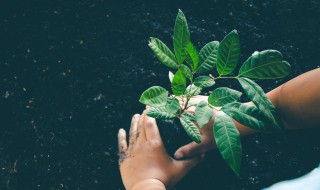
[174,142,206,159]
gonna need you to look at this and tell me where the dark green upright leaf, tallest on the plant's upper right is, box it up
[217,30,240,75]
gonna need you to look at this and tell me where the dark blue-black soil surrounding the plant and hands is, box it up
[0,0,320,190]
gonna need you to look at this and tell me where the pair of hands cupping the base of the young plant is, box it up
[118,97,215,189]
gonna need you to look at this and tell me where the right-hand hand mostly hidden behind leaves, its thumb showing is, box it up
[174,96,216,159]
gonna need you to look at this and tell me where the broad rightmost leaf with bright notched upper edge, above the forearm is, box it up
[239,50,291,79]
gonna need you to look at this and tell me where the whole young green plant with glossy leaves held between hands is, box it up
[140,10,291,175]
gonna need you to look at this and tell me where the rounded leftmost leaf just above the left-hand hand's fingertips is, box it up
[139,86,168,107]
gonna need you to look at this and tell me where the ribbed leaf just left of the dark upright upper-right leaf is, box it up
[196,41,219,73]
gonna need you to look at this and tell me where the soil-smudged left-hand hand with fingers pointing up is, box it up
[118,111,203,189]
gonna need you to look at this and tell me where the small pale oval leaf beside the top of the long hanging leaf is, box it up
[195,101,213,128]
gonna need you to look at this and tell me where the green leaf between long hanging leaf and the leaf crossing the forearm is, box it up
[222,102,268,131]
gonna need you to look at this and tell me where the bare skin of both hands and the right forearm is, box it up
[118,69,320,190]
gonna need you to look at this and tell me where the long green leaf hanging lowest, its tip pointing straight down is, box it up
[213,111,242,176]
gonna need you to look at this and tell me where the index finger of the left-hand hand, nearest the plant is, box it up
[143,115,161,140]
